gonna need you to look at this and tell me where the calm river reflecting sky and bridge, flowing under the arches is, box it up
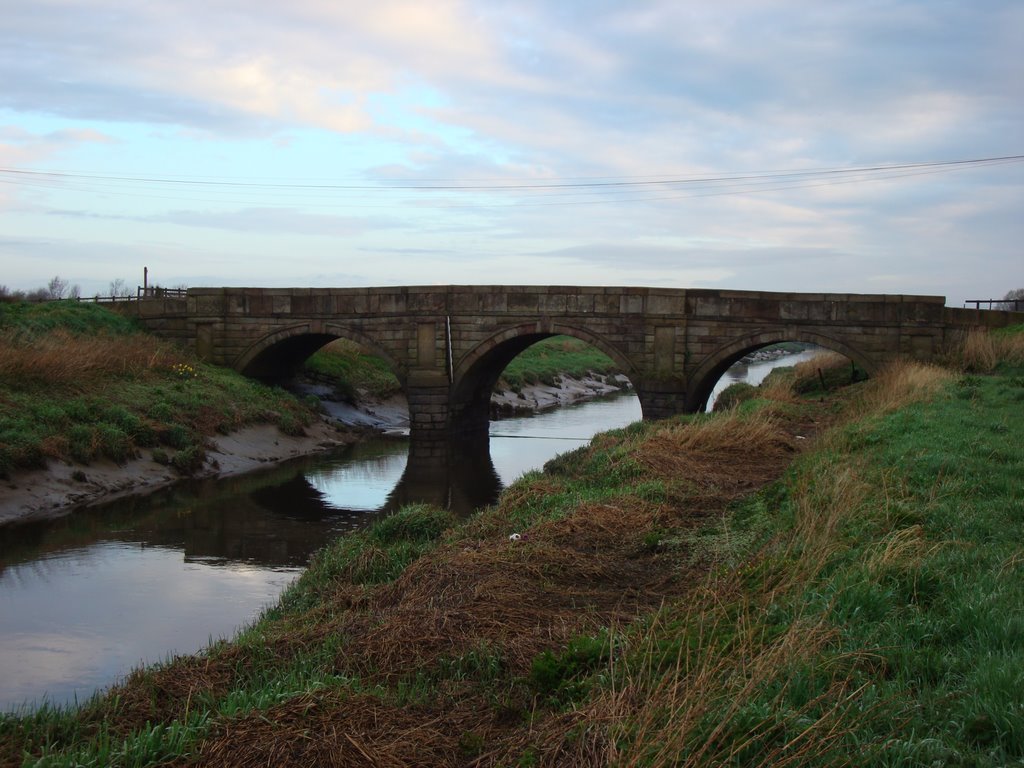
[0,348,805,712]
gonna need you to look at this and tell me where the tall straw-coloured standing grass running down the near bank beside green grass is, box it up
[483,418,884,767]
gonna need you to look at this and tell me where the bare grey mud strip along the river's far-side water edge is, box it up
[0,370,628,525]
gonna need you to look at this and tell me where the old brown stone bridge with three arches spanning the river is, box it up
[123,286,1024,437]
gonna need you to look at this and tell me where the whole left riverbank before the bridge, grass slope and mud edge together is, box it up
[0,302,355,524]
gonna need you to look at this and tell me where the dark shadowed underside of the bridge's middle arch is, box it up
[449,323,638,434]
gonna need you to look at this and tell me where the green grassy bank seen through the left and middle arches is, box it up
[305,336,616,400]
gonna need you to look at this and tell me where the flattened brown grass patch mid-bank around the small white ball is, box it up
[343,499,678,677]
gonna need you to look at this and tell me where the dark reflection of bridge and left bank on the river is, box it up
[0,436,502,575]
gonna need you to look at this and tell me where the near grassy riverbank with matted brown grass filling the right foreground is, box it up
[6,333,1024,766]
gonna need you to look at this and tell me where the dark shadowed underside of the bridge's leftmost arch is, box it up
[232,323,406,389]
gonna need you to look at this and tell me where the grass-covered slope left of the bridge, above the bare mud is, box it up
[0,302,312,476]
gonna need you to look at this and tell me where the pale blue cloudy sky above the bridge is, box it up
[0,0,1024,306]
